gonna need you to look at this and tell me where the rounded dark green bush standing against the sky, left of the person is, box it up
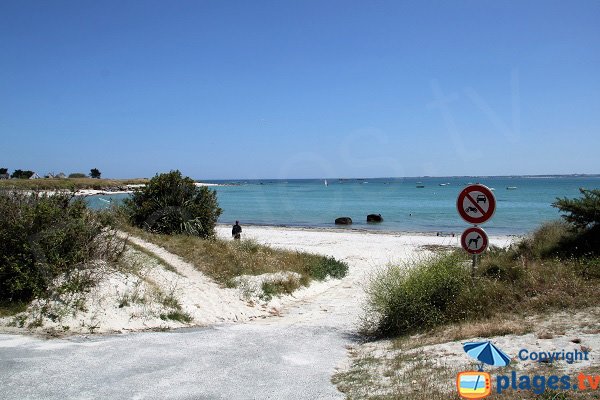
[124,171,222,238]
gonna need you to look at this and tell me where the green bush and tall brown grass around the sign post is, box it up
[364,217,600,336]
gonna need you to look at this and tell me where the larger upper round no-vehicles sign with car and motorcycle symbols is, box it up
[456,184,496,225]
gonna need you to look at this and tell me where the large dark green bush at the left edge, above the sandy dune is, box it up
[0,191,119,302]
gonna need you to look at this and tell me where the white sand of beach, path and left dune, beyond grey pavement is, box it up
[0,226,514,333]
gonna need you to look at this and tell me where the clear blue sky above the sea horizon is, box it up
[0,0,600,179]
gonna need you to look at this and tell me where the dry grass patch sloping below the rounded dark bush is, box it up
[122,226,348,297]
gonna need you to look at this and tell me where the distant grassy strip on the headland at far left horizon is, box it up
[0,178,148,190]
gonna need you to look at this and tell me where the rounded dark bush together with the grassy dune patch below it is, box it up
[119,171,348,299]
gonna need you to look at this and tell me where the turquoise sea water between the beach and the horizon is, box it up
[89,177,600,234]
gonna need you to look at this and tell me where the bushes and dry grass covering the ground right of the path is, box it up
[333,189,600,399]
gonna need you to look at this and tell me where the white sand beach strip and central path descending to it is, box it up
[217,226,516,331]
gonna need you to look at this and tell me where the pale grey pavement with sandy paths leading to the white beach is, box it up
[0,227,509,400]
